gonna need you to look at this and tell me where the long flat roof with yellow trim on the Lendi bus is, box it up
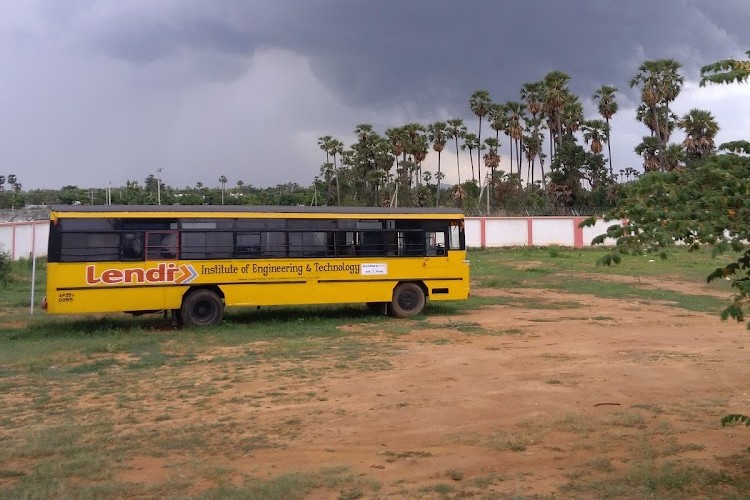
[50,205,464,218]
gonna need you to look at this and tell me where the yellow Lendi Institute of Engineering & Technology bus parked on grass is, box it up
[43,205,469,326]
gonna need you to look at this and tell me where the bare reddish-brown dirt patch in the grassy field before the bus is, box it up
[111,282,750,498]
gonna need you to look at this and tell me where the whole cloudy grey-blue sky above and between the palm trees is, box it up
[0,0,750,189]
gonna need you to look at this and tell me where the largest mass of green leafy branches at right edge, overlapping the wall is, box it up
[588,154,750,321]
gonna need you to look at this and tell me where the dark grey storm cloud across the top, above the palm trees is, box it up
[69,0,750,111]
